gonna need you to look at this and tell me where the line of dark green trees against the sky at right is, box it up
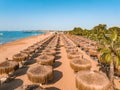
[66,24,120,37]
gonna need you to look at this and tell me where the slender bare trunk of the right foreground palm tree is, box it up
[109,59,115,90]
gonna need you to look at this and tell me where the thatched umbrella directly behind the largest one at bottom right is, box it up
[70,58,91,71]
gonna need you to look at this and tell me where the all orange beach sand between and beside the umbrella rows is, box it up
[0,33,120,90]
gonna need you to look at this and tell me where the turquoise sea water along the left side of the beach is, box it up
[0,31,44,44]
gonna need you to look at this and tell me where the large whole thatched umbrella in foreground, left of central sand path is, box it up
[27,64,53,84]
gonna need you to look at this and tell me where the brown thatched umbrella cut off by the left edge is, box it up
[0,60,19,74]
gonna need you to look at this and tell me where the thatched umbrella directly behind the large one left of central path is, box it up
[35,54,55,65]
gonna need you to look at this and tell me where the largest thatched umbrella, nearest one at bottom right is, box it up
[76,70,111,90]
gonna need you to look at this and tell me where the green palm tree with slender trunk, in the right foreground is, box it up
[99,30,120,90]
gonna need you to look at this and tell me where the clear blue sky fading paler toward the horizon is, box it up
[0,0,120,30]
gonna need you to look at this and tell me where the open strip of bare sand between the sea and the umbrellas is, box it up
[0,33,51,63]
